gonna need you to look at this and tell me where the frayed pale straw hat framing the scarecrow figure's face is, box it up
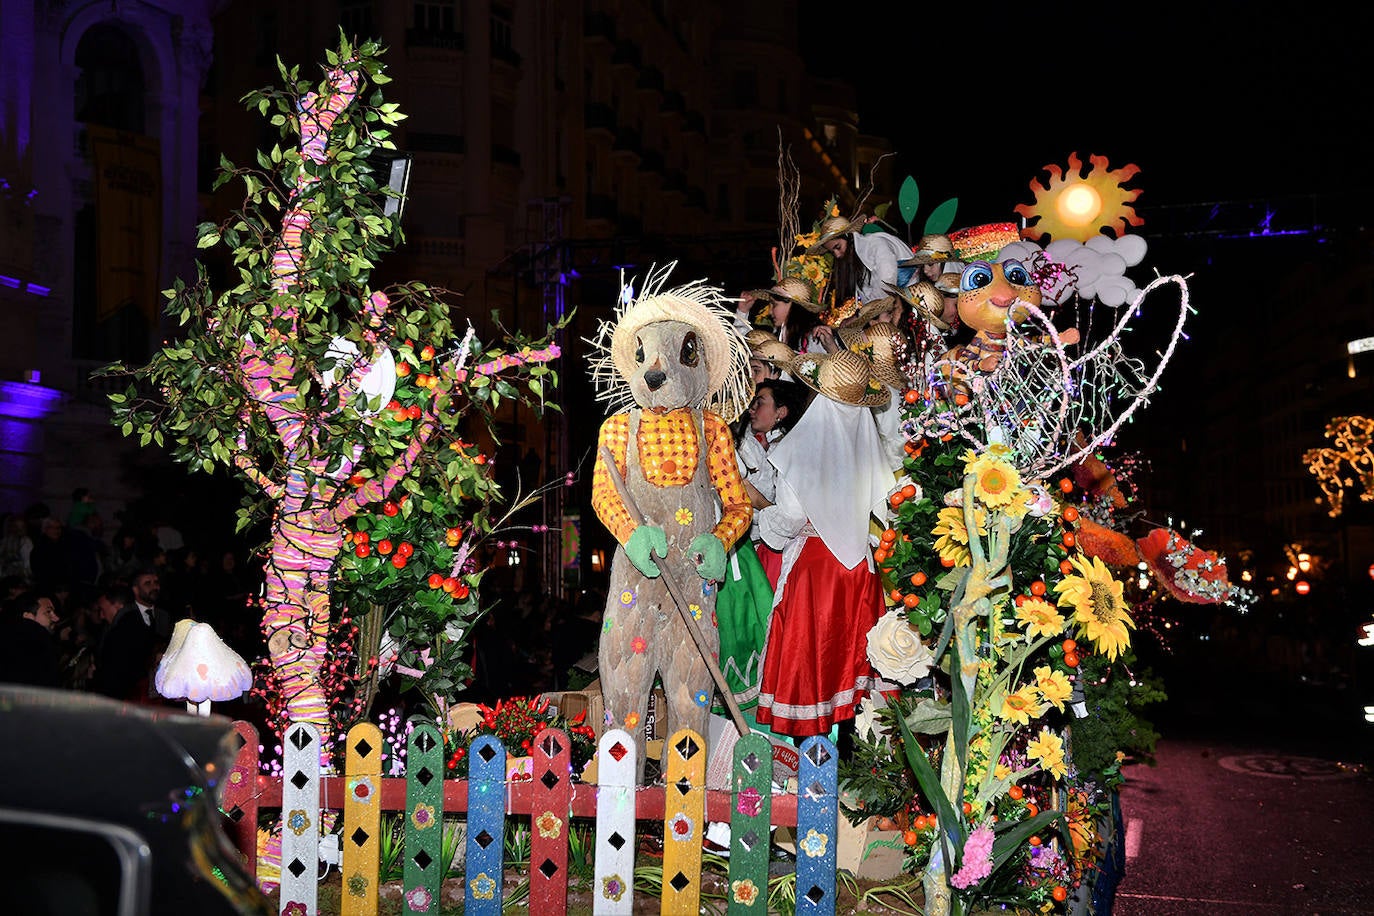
[587,261,753,422]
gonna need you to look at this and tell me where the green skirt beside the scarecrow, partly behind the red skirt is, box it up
[716,537,772,713]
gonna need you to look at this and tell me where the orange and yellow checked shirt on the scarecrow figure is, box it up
[592,408,753,551]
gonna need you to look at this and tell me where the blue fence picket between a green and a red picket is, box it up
[463,735,506,916]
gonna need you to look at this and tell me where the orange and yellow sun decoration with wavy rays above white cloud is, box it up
[1015,152,1145,242]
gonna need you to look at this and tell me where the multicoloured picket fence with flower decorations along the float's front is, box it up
[223,722,840,916]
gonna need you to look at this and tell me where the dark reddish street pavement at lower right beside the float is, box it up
[1113,670,1374,916]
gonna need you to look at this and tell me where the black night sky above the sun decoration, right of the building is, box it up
[801,10,1374,225]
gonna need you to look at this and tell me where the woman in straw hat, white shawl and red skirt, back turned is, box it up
[756,350,892,737]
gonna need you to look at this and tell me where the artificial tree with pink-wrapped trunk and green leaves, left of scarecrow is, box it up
[107,38,558,746]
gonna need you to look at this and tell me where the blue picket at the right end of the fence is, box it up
[797,735,840,916]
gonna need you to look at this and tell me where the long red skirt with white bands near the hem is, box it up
[754,536,885,737]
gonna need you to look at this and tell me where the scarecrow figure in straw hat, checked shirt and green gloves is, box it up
[592,265,753,776]
